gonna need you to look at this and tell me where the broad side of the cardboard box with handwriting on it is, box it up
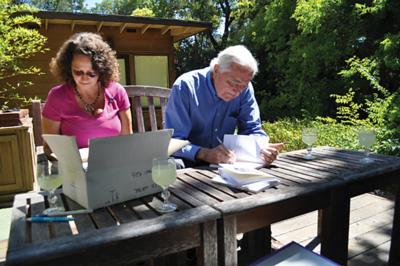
[86,130,172,209]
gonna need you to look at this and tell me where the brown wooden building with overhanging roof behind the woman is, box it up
[22,11,211,99]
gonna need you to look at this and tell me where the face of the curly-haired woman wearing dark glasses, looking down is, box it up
[71,54,99,88]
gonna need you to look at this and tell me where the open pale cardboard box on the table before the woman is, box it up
[43,129,172,209]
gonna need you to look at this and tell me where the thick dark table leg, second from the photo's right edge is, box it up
[318,186,350,265]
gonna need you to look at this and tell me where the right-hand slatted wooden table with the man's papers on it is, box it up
[172,147,400,265]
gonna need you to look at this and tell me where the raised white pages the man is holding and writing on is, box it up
[223,134,269,168]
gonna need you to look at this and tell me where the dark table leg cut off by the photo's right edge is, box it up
[388,186,400,266]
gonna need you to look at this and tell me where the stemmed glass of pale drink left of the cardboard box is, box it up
[36,160,65,215]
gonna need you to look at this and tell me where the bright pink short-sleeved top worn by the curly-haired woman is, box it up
[42,82,130,148]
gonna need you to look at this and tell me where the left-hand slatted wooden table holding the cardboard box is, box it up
[6,190,220,265]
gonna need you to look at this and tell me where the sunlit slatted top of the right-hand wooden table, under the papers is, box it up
[175,147,400,214]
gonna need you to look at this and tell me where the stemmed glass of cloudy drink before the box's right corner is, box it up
[151,158,176,213]
